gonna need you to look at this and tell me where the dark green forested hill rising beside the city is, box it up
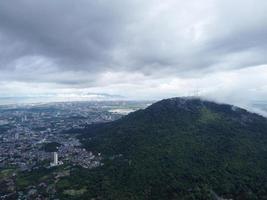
[66,98,267,200]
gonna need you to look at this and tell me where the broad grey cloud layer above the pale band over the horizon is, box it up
[0,0,267,87]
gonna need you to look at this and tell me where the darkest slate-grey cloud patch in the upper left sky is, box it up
[0,0,141,69]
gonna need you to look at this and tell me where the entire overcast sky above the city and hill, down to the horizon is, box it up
[0,0,267,108]
